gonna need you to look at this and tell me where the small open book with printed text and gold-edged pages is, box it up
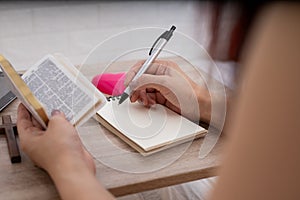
[0,55,106,128]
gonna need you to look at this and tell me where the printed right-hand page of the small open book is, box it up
[22,56,105,124]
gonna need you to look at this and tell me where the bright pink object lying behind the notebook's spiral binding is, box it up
[92,72,126,96]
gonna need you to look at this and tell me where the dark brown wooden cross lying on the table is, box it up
[0,115,21,163]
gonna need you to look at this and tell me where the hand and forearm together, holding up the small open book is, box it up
[17,104,113,200]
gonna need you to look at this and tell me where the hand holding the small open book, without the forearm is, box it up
[17,104,95,175]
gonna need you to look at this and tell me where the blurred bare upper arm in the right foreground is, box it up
[212,3,300,200]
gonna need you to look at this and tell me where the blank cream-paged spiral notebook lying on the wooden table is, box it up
[96,97,207,156]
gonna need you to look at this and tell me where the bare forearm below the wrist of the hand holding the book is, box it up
[49,160,114,200]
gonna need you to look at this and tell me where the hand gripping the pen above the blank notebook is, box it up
[125,60,210,122]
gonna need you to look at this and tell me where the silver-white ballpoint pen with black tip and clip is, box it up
[119,26,176,105]
